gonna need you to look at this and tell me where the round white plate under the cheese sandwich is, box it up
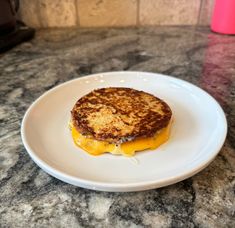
[21,72,227,192]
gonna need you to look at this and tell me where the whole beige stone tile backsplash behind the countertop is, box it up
[19,0,214,28]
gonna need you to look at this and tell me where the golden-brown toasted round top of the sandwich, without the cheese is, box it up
[71,87,172,144]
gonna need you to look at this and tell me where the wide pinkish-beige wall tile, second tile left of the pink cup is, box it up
[139,0,200,25]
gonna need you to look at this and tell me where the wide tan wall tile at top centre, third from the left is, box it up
[77,0,137,27]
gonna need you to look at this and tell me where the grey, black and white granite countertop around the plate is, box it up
[0,27,235,227]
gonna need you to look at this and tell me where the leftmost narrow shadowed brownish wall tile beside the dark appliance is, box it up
[19,0,41,28]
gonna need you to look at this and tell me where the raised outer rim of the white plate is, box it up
[20,71,228,192]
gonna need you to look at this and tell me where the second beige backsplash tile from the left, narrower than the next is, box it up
[38,0,77,27]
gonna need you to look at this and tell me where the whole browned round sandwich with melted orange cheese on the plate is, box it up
[71,87,172,156]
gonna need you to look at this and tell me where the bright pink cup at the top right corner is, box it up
[211,0,235,34]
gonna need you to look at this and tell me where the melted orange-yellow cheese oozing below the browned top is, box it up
[71,121,172,157]
